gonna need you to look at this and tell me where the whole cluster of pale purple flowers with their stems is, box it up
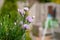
[18,7,33,29]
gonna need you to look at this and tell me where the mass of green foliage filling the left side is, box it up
[0,0,32,40]
